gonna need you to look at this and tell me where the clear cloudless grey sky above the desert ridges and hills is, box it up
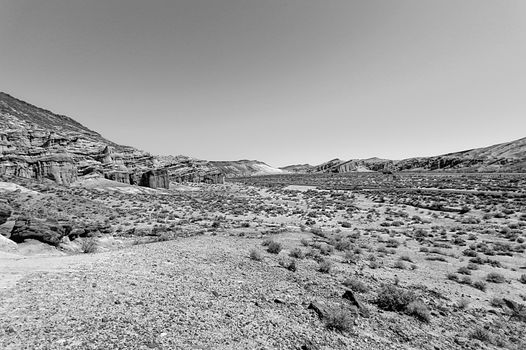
[0,0,526,166]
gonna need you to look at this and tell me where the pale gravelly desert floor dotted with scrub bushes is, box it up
[0,173,526,349]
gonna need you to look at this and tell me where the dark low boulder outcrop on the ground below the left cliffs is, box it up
[11,217,72,246]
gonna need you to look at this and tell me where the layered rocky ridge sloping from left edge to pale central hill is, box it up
[0,92,283,188]
